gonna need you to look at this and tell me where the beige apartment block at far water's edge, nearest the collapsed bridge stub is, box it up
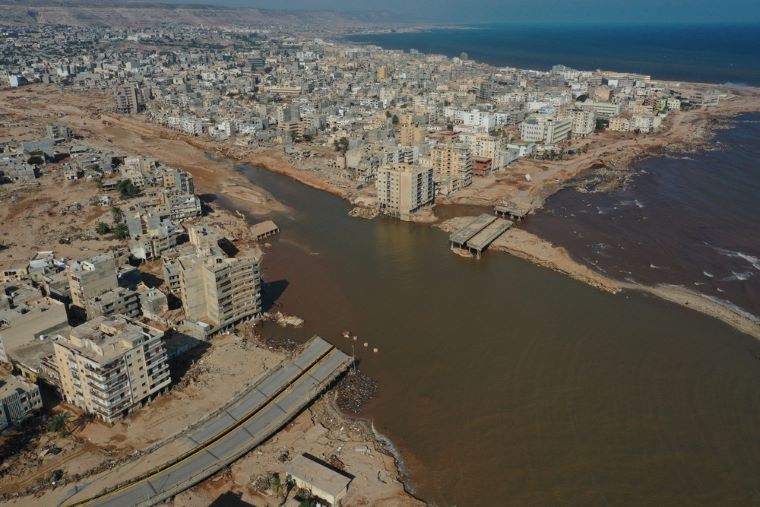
[375,164,435,220]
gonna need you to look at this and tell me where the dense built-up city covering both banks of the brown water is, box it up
[0,17,748,505]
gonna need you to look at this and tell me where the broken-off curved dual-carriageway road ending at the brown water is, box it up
[67,337,352,506]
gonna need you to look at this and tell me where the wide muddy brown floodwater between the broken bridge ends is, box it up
[220,167,760,506]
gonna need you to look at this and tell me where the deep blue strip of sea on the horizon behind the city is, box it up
[348,23,760,86]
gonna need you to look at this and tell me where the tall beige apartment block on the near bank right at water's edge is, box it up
[178,253,261,332]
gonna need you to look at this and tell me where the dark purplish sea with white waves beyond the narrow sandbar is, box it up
[525,113,760,322]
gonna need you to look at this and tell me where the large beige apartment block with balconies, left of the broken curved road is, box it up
[54,315,171,423]
